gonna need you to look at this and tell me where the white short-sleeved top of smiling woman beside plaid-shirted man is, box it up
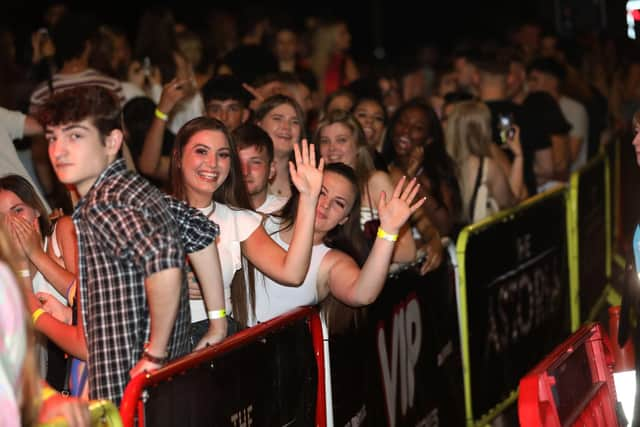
[189,202,262,322]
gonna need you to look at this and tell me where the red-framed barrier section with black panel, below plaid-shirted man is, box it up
[120,307,326,427]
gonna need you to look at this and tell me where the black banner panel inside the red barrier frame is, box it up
[143,319,317,427]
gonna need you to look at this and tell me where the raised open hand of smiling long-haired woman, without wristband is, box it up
[289,139,324,200]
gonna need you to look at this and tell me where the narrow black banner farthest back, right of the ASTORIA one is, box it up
[578,160,607,322]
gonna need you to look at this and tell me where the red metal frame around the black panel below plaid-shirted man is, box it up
[120,307,326,427]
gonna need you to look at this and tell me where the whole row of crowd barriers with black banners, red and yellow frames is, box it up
[110,139,621,426]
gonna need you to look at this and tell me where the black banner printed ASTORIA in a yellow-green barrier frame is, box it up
[465,192,571,419]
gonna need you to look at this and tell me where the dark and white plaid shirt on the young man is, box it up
[73,159,219,405]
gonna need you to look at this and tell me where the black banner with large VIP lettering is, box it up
[330,263,464,427]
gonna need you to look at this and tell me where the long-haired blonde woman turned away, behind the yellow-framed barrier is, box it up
[445,101,524,222]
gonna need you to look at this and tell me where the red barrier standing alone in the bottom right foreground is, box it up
[518,323,618,427]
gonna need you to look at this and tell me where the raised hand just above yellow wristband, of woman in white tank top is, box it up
[378,176,426,234]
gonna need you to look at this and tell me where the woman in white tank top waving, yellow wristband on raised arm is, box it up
[248,163,424,325]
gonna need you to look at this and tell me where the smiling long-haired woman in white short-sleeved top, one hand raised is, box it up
[171,117,324,335]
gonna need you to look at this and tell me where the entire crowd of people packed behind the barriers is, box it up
[0,4,640,420]
